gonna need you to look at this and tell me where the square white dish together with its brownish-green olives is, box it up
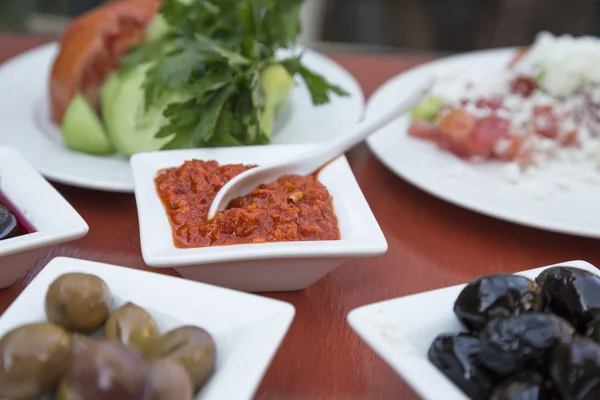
[0,258,294,400]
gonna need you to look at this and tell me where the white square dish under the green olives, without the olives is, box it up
[0,257,295,400]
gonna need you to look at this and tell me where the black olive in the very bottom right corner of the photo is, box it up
[550,337,600,400]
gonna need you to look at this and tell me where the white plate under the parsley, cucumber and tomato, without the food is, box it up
[0,43,364,192]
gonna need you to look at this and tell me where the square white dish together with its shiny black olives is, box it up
[349,261,600,400]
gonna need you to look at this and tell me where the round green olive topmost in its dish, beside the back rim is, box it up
[45,273,112,334]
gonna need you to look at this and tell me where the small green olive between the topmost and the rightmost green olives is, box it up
[104,303,158,356]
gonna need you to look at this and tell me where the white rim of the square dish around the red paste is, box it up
[131,145,387,267]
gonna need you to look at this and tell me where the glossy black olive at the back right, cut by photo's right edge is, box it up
[536,267,600,333]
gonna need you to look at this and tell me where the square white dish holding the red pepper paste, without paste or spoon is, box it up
[131,145,387,292]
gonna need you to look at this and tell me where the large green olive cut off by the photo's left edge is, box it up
[0,322,71,400]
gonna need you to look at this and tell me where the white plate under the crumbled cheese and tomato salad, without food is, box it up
[367,49,600,238]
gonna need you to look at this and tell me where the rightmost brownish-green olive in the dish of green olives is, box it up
[150,326,217,390]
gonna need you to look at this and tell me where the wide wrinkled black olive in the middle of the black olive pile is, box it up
[479,313,575,376]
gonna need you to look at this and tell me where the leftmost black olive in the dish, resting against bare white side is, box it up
[428,333,495,400]
